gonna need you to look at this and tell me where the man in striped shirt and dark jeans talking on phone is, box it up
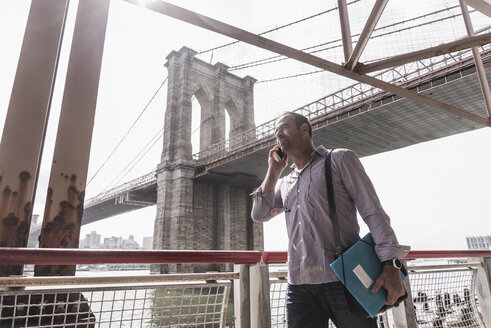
[252,112,409,328]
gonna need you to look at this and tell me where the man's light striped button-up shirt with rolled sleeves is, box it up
[252,146,410,285]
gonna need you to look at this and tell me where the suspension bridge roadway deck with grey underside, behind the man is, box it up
[78,51,491,224]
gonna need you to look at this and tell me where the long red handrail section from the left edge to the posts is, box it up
[0,247,261,265]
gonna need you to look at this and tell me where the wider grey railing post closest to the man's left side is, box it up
[249,262,271,328]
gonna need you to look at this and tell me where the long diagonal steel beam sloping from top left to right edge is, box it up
[125,0,491,126]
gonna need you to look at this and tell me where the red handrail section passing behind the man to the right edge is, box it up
[262,250,491,264]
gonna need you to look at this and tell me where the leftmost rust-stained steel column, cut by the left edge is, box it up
[0,0,68,277]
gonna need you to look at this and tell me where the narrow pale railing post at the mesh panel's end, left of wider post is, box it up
[234,264,251,328]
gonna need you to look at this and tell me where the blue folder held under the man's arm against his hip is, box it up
[331,233,406,318]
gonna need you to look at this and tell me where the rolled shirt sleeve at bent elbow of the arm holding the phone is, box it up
[251,180,285,222]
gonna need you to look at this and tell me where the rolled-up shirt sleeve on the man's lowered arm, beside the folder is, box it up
[339,150,411,261]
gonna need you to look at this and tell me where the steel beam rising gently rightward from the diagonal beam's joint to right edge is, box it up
[357,32,491,74]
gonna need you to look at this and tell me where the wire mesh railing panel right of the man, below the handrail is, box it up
[410,267,485,328]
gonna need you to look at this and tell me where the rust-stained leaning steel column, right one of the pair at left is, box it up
[35,0,109,276]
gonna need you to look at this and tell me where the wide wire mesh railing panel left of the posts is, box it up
[0,282,231,328]
